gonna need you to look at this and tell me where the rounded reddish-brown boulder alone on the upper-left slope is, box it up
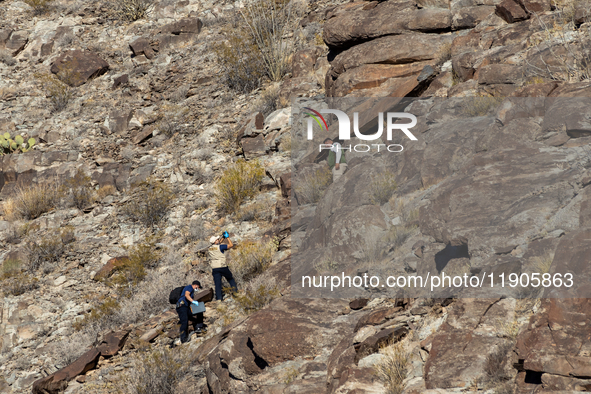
[51,50,109,86]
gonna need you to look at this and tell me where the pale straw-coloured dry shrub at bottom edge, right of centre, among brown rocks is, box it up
[374,342,409,394]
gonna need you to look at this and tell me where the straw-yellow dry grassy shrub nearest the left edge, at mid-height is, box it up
[4,183,59,220]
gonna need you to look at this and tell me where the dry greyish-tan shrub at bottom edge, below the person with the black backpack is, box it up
[118,347,193,394]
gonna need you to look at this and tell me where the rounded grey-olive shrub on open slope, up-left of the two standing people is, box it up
[123,179,174,228]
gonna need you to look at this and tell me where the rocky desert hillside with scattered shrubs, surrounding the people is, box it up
[0,0,591,394]
